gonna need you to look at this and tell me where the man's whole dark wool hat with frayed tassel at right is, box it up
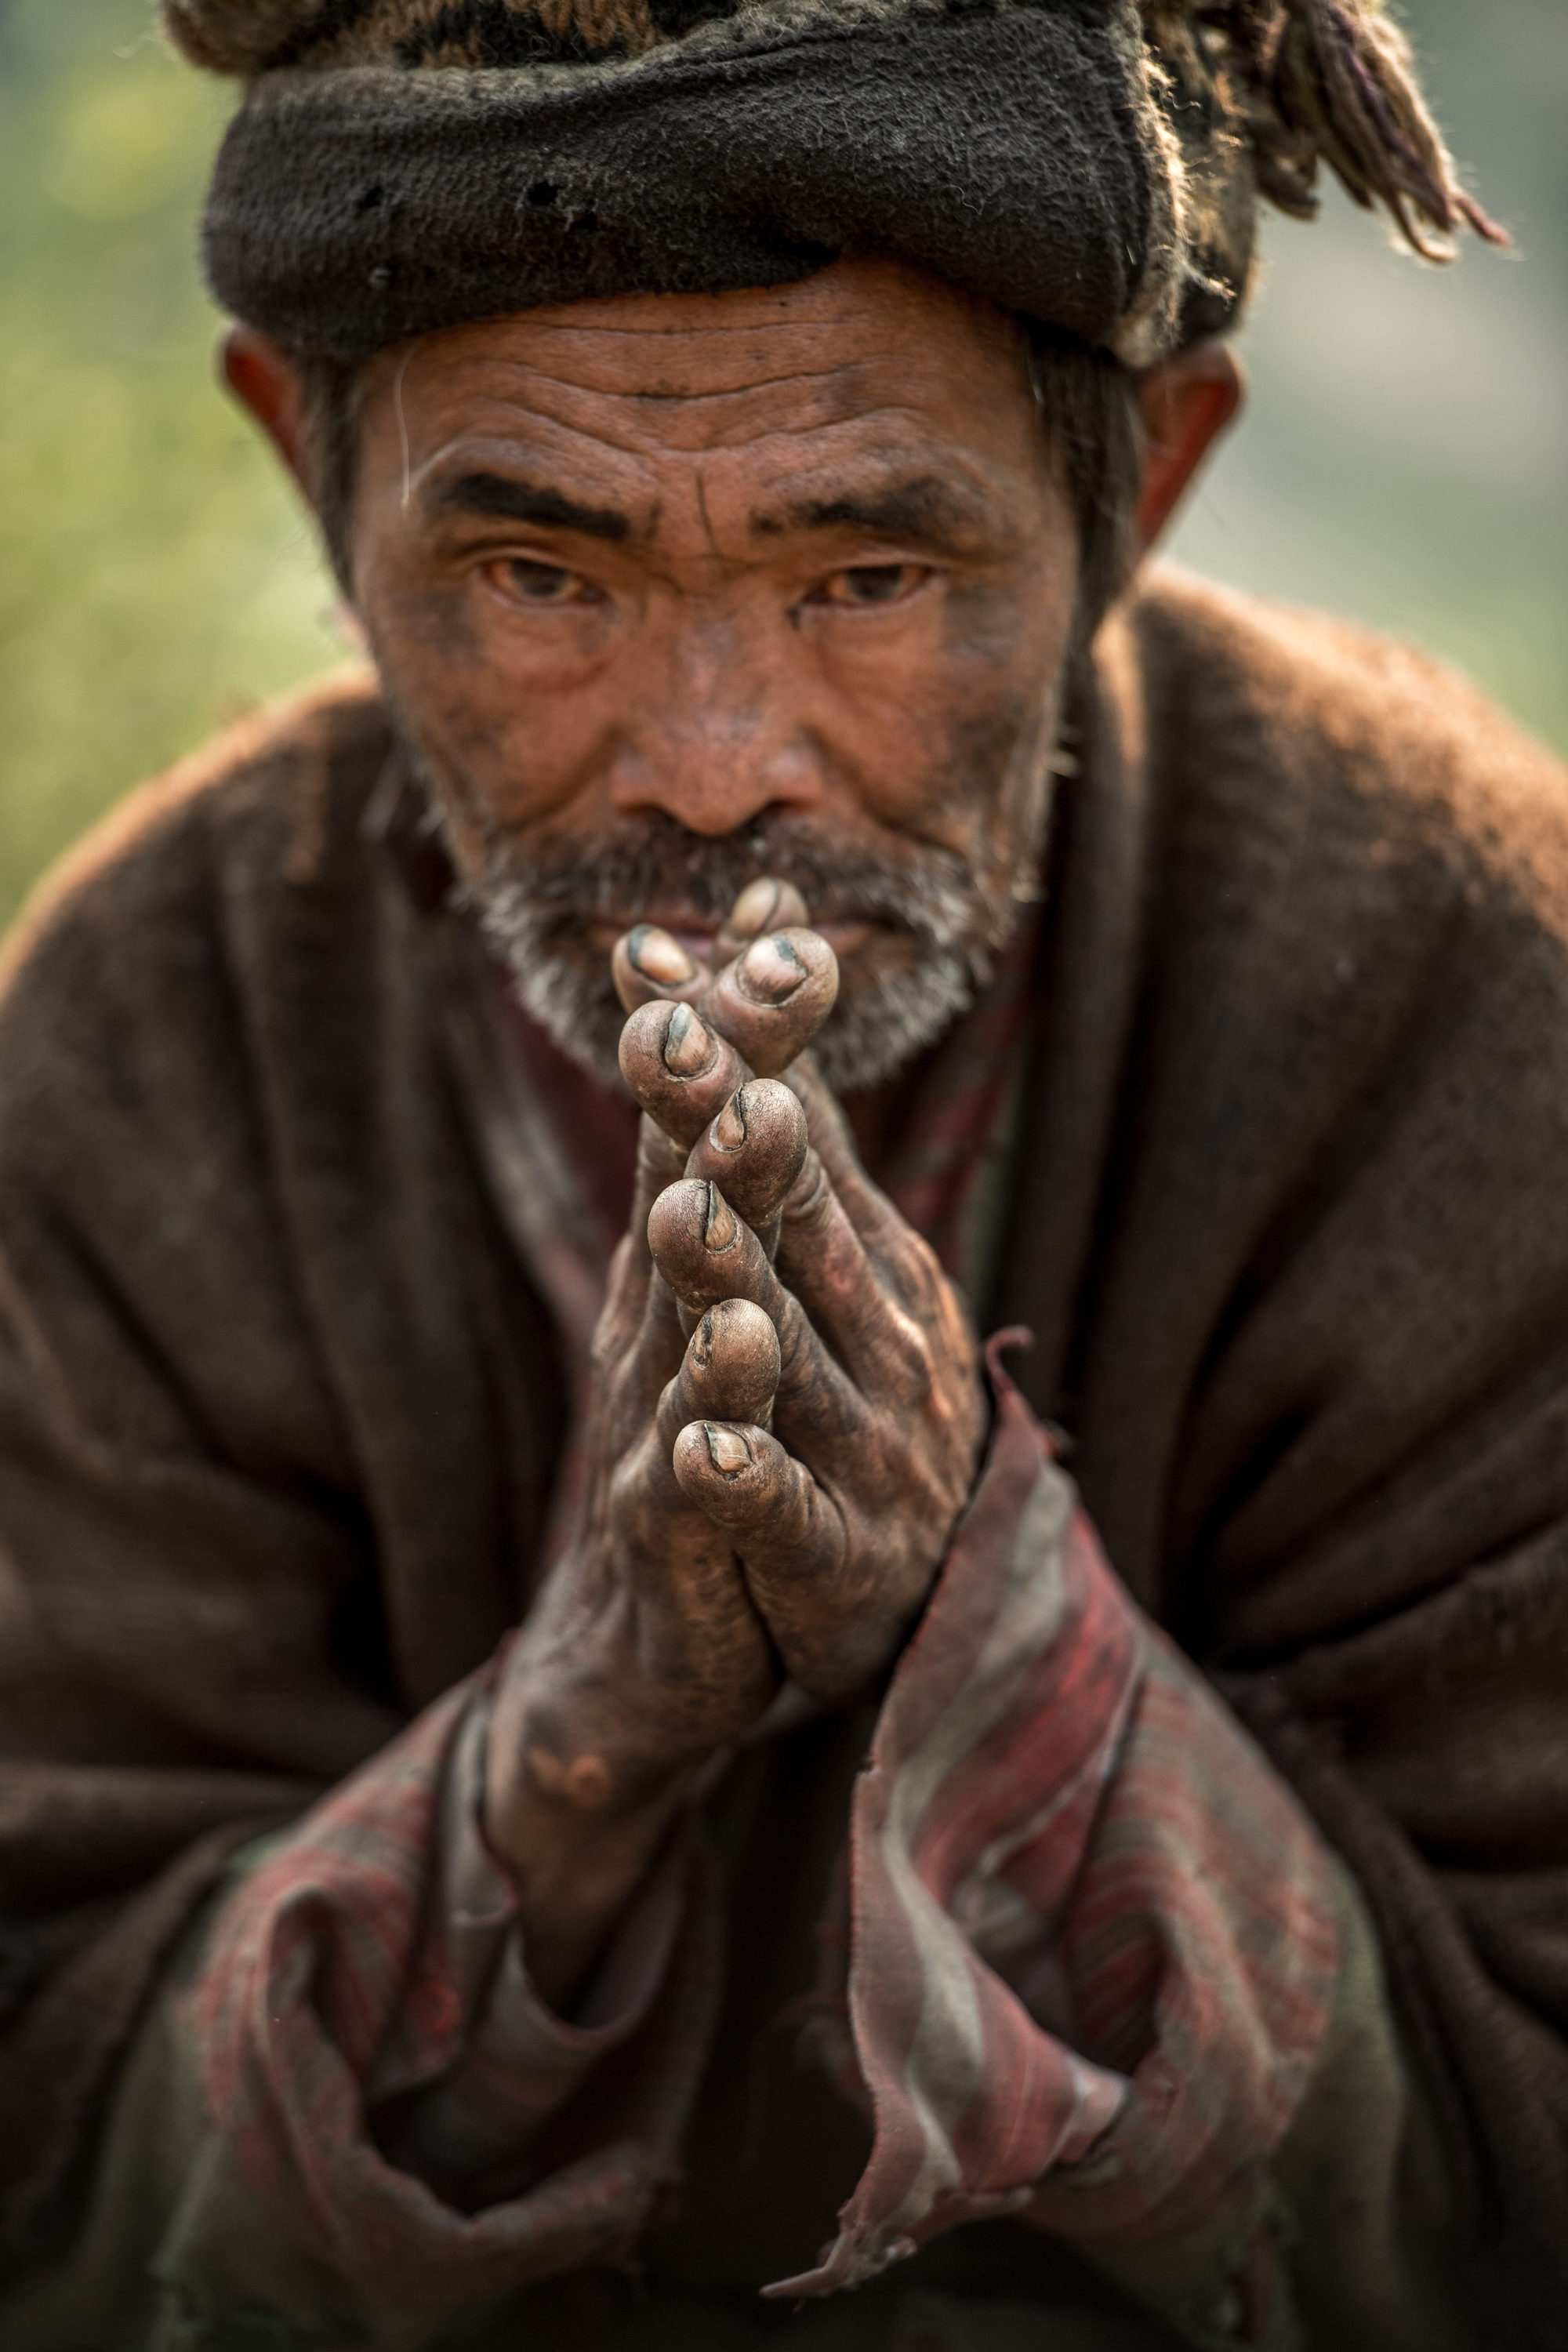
[165,0,1502,367]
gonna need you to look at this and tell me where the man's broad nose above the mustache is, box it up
[609,600,822,835]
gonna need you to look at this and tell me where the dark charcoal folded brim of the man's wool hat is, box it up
[205,0,1203,358]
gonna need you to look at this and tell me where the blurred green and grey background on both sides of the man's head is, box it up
[0,0,1568,922]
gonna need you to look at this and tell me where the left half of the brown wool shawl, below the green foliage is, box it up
[0,687,573,2258]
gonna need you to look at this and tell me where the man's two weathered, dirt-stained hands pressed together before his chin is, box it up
[487,882,985,1978]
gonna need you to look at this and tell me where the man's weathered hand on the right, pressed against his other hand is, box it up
[602,884,985,1700]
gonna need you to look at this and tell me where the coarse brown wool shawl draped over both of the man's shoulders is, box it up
[0,574,1568,2352]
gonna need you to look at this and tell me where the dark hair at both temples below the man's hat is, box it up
[294,320,1140,647]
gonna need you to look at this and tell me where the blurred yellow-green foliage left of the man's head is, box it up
[0,0,341,920]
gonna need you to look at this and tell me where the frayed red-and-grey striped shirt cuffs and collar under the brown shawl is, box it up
[180,818,1338,2343]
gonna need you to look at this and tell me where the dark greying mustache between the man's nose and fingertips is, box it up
[477,809,1013,948]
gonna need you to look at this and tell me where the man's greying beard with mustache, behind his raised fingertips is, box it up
[421,769,1039,1094]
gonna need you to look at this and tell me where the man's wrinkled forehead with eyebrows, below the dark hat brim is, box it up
[343,263,1055,560]
